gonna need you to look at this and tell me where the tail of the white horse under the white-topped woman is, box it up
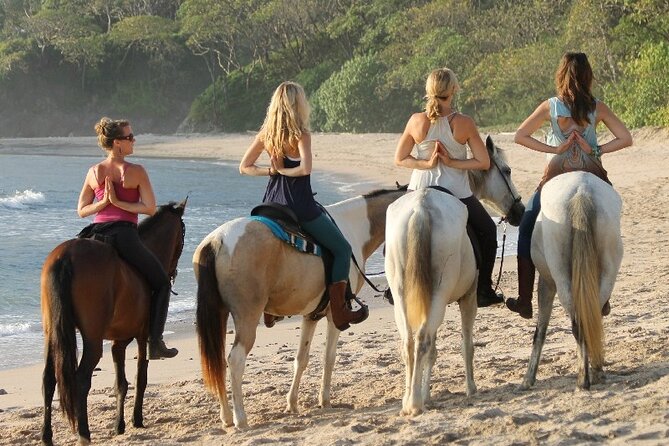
[404,207,432,331]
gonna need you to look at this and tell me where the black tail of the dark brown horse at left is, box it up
[42,255,77,429]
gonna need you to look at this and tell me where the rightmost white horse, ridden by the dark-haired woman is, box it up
[521,172,623,389]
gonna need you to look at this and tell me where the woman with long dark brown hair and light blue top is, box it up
[506,53,632,319]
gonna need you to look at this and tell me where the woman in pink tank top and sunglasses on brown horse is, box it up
[77,118,178,359]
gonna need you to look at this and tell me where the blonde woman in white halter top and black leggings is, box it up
[395,68,504,307]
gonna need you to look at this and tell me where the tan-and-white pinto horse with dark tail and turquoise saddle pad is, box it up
[193,188,406,428]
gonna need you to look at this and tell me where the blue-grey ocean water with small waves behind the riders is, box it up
[0,152,516,370]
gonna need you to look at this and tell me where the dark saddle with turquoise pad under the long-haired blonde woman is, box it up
[251,203,334,321]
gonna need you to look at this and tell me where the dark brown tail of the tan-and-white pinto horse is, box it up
[195,243,230,397]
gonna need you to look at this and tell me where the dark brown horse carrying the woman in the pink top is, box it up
[41,200,186,444]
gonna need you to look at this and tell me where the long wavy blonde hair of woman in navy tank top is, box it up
[260,82,311,157]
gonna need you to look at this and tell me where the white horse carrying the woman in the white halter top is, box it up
[385,137,524,415]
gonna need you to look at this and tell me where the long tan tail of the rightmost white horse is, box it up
[569,192,604,366]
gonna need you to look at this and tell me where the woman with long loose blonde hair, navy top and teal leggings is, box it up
[239,82,368,330]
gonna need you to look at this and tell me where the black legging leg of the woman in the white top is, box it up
[460,195,497,291]
